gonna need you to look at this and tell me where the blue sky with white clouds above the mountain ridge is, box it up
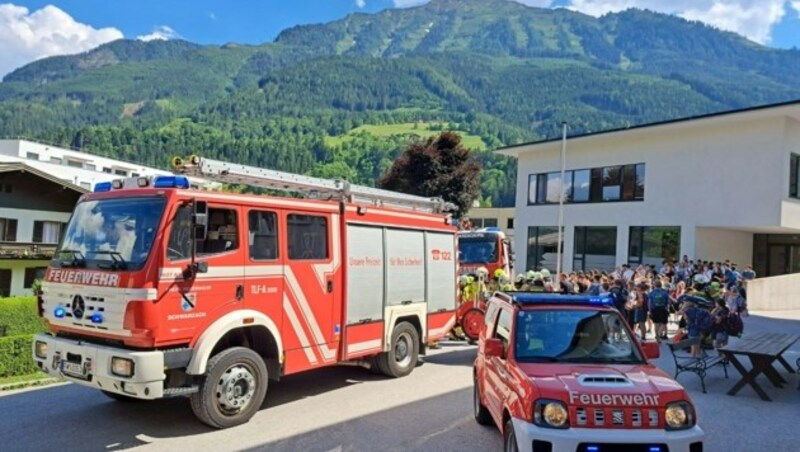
[0,0,800,76]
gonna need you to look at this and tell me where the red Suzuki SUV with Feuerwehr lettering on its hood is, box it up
[473,292,704,452]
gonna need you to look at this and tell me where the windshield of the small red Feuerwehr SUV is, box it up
[514,309,646,364]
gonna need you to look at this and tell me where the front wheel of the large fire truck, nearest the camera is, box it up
[190,347,268,428]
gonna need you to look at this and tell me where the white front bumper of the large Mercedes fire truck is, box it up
[32,334,166,400]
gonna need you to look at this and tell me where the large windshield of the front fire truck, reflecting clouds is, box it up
[53,197,166,270]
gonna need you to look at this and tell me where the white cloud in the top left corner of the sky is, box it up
[0,3,123,77]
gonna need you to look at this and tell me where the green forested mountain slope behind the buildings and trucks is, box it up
[0,0,800,206]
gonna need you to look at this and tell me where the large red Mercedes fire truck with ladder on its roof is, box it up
[33,157,457,428]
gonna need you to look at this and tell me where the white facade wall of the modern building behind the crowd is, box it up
[515,117,800,270]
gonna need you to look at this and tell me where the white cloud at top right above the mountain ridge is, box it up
[568,0,788,44]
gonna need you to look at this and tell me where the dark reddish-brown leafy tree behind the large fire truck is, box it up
[378,132,481,215]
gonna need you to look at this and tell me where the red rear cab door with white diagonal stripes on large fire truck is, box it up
[282,211,342,373]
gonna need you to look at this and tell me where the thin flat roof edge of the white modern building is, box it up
[495,100,800,157]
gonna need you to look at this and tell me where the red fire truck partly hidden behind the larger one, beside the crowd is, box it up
[458,228,514,278]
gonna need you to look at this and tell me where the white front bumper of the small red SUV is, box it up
[512,418,705,452]
